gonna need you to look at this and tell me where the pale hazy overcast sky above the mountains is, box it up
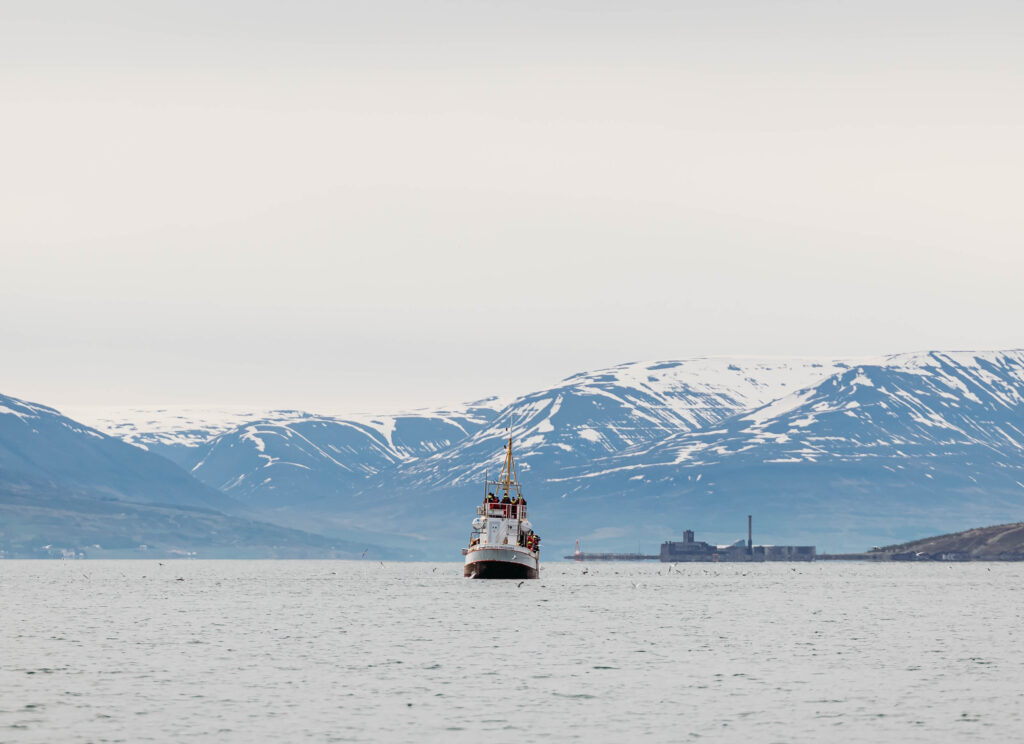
[0,0,1024,410]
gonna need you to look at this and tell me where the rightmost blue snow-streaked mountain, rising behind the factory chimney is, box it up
[546,351,1024,550]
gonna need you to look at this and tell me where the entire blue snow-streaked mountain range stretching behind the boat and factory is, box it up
[59,351,1024,555]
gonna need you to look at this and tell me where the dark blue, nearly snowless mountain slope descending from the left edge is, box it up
[0,396,399,557]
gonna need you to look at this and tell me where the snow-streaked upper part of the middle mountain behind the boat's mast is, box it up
[380,357,847,489]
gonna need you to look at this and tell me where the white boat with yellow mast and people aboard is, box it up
[462,434,541,578]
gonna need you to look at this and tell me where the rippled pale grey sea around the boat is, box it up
[0,561,1024,742]
